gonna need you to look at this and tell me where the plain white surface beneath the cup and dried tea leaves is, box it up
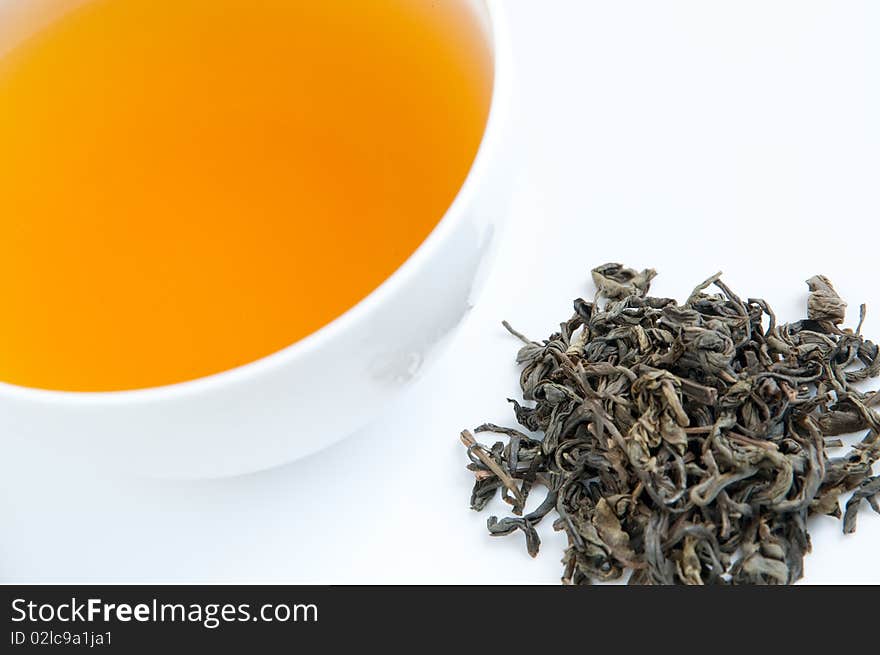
[0,0,880,583]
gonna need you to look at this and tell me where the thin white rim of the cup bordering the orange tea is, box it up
[0,0,512,405]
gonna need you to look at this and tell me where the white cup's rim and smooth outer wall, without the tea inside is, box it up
[0,0,513,478]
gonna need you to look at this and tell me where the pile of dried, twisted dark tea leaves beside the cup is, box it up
[462,264,880,584]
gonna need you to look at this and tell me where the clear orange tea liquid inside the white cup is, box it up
[0,0,492,391]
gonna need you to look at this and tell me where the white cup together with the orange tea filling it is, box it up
[0,0,510,477]
